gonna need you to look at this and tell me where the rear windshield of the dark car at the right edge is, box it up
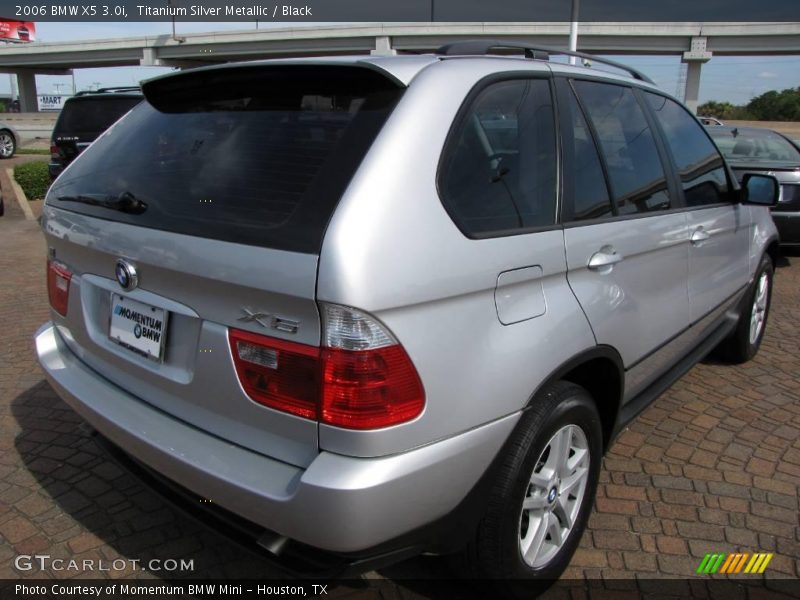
[706,127,800,163]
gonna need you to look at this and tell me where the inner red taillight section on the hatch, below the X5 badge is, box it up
[228,329,319,419]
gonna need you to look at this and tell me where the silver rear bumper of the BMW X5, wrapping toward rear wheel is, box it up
[35,323,519,553]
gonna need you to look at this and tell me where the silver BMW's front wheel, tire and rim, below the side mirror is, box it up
[718,255,774,364]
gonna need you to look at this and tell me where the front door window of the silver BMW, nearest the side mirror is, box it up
[645,93,728,206]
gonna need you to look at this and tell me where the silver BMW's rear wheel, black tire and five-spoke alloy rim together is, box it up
[466,381,603,594]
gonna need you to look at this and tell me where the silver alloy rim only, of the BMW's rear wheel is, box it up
[519,425,591,568]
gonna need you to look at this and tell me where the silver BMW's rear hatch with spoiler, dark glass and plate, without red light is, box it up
[43,64,404,466]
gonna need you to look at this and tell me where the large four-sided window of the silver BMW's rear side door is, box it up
[574,81,670,215]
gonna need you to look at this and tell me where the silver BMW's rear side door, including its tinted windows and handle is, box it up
[559,81,689,376]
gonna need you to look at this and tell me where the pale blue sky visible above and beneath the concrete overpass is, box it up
[6,22,800,104]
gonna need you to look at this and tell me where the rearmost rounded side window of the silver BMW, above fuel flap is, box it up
[439,79,556,236]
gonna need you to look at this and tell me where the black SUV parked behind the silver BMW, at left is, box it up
[48,87,143,181]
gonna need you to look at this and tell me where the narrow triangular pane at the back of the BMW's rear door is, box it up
[564,86,613,221]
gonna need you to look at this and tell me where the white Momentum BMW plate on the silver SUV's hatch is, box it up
[108,292,169,363]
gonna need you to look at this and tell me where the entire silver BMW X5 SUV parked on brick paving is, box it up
[36,41,778,579]
